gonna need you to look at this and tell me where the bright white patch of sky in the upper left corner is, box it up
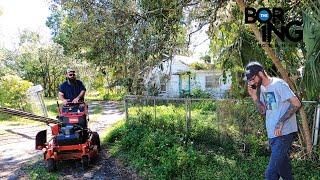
[0,0,50,49]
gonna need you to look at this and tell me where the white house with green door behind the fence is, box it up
[145,55,231,98]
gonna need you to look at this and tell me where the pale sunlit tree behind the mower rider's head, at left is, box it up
[0,30,71,97]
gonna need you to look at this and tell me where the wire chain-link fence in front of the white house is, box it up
[125,96,320,151]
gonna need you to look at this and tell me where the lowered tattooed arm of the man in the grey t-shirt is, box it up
[274,96,301,136]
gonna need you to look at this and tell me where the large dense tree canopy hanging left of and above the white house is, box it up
[47,0,186,93]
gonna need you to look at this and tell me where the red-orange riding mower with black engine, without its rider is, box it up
[35,102,100,172]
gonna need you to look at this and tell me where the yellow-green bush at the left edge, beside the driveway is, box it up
[0,75,32,110]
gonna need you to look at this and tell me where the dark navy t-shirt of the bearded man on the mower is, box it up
[59,80,86,101]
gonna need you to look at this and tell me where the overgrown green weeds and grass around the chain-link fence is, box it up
[105,102,320,179]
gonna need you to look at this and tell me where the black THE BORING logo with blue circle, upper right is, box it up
[245,8,303,42]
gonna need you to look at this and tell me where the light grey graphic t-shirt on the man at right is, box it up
[260,78,298,138]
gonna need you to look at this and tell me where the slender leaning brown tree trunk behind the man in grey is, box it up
[236,0,312,154]
